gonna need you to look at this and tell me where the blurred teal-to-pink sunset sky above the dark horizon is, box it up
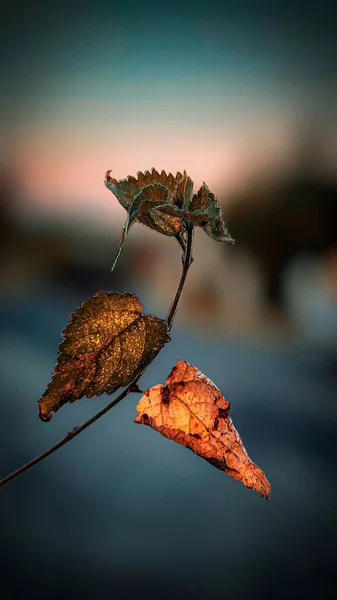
[1,2,336,225]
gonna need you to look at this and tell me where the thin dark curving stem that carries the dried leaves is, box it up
[0,227,193,486]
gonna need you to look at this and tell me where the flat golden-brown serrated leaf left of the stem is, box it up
[39,292,170,421]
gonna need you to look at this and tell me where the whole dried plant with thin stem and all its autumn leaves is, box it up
[1,169,270,499]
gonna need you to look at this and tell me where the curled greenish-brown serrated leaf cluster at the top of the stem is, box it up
[104,169,234,269]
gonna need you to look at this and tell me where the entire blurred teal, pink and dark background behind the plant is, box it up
[0,0,337,600]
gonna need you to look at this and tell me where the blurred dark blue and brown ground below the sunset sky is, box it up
[0,149,337,599]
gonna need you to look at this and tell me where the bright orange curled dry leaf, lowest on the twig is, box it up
[135,360,270,499]
